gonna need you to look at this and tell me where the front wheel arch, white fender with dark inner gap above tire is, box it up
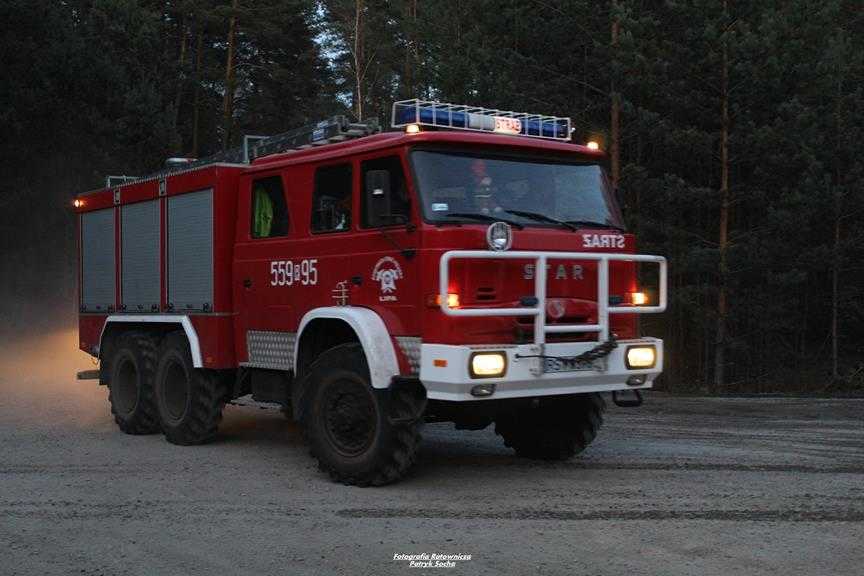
[294,306,399,388]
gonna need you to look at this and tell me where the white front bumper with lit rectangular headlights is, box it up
[420,338,663,401]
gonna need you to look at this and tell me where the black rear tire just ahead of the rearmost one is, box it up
[154,332,227,446]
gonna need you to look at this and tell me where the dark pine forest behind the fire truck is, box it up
[0,0,864,392]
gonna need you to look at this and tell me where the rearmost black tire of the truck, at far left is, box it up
[105,332,159,434]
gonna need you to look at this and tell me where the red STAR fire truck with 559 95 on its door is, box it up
[75,100,667,485]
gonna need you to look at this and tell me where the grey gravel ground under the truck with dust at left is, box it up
[0,331,864,576]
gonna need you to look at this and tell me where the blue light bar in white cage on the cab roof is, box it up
[392,99,570,140]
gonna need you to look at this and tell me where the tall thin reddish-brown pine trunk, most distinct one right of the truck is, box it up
[714,0,729,392]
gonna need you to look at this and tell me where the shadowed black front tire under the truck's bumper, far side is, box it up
[495,394,606,460]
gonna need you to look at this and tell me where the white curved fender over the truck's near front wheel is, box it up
[294,306,399,388]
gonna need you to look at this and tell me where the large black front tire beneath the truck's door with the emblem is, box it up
[299,343,426,486]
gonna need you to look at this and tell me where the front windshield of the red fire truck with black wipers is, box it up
[411,150,622,228]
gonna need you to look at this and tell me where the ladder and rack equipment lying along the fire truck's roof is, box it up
[105,116,381,188]
